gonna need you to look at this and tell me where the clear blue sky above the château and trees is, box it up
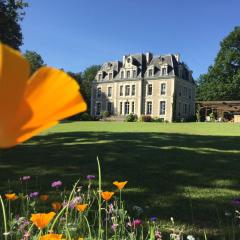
[21,0,240,78]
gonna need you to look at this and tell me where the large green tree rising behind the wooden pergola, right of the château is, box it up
[197,27,240,100]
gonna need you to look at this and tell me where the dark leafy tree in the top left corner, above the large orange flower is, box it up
[0,0,28,49]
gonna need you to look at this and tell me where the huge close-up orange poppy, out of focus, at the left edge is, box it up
[0,44,87,148]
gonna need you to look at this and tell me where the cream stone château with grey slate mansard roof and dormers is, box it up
[91,53,195,121]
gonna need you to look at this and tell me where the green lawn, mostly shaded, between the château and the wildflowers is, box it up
[0,122,240,237]
